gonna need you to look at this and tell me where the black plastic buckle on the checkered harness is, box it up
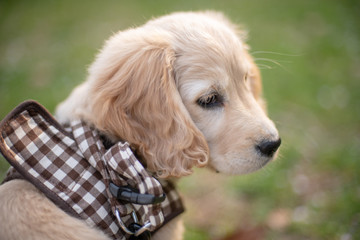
[109,182,166,205]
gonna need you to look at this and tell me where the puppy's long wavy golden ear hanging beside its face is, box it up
[87,29,209,177]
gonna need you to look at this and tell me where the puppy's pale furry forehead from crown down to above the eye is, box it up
[153,13,250,98]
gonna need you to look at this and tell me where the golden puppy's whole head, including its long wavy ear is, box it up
[57,13,280,177]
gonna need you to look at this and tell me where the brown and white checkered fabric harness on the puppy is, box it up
[0,101,183,239]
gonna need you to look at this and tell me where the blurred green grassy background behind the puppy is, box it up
[0,0,360,240]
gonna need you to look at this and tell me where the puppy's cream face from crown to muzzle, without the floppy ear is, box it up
[153,14,280,174]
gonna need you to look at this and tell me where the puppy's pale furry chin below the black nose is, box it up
[208,154,277,175]
